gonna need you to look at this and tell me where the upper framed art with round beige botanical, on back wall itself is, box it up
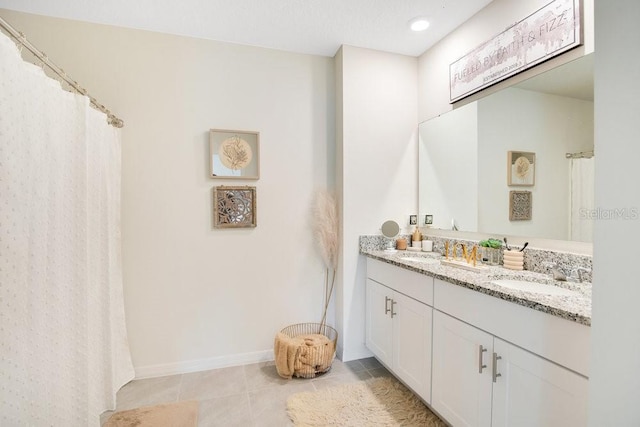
[209,129,260,179]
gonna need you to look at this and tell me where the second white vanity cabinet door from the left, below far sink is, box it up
[392,292,433,403]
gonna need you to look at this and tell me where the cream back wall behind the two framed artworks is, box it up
[1,10,338,376]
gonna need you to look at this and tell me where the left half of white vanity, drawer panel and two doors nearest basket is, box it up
[366,259,433,402]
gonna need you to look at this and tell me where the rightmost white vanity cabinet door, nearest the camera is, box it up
[493,338,588,427]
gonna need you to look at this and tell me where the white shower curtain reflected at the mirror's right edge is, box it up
[570,157,595,242]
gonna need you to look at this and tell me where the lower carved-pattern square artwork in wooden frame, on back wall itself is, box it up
[213,185,256,228]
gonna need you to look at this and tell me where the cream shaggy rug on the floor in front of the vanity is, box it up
[287,377,446,427]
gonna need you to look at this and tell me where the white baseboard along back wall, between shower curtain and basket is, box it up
[135,349,274,380]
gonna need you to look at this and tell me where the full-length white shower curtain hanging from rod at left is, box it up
[0,33,134,426]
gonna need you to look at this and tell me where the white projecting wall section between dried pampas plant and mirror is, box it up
[336,46,418,360]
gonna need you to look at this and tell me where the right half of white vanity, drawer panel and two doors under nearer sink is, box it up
[431,280,589,427]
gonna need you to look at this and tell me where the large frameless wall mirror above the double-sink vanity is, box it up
[418,54,594,242]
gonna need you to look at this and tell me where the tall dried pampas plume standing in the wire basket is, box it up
[312,190,339,330]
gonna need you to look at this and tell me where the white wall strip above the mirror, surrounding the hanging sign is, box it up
[418,0,594,122]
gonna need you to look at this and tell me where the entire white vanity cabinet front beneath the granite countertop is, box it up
[366,258,590,427]
